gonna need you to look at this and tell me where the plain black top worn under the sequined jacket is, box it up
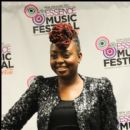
[49,100,79,130]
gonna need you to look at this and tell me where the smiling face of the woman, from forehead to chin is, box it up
[50,41,82,78]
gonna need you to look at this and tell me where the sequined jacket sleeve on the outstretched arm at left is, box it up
[1,75,41,130]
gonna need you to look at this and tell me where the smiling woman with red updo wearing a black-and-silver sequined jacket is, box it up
[2,23,118,130]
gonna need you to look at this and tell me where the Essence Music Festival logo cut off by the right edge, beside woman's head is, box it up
[95,36,130,68]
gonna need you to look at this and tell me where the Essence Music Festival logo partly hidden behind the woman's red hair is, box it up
[24,4,80,35]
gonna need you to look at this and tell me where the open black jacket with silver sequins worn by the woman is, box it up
[1,75,118,130]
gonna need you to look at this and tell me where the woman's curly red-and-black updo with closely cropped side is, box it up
[49,23,81,52]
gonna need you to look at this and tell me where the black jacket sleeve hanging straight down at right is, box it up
[99,78,118,130]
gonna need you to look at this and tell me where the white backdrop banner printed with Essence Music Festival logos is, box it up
[1,2,130,130]
